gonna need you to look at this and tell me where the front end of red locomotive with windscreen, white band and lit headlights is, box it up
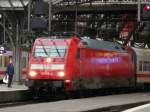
[27,38,68,88]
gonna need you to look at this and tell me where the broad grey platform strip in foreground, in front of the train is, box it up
[0,93,150,112]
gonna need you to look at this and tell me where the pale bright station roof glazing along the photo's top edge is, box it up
[0,0,150,10]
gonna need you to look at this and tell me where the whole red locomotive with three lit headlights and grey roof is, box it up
[27,35,135,91]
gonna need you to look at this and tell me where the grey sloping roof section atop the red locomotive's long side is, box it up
[81,38,124,52]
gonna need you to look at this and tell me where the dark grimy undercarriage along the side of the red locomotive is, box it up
[73,77,135,90]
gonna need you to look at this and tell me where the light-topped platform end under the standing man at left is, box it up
[0,83,28,103]
